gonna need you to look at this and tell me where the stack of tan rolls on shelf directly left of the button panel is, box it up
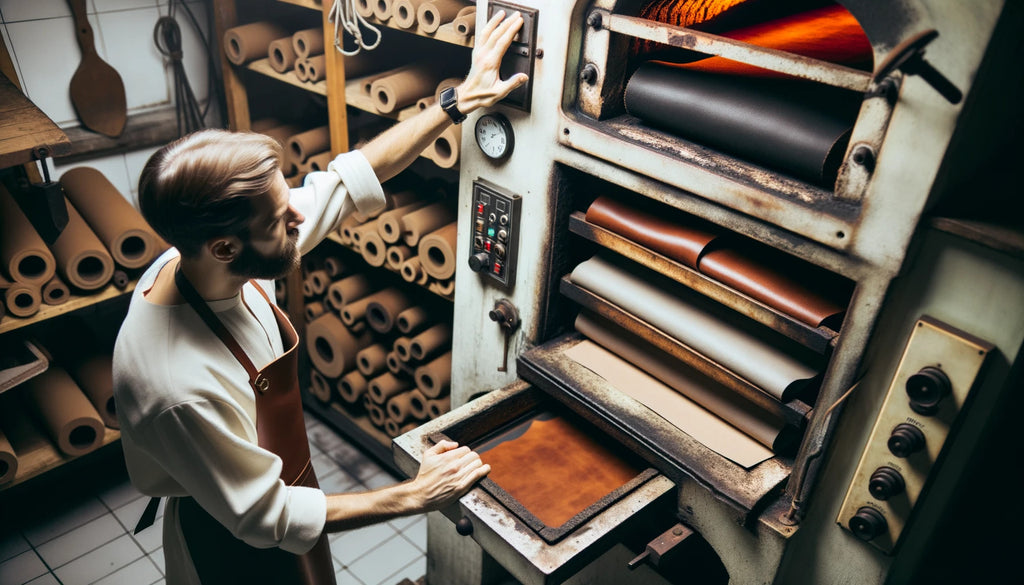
[339,182,457,298]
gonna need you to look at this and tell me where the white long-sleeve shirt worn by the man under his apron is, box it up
[114,151,385,585]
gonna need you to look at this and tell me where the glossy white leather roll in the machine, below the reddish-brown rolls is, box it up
[570,256,818,402]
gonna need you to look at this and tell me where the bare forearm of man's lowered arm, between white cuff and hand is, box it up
[324,482,427,533]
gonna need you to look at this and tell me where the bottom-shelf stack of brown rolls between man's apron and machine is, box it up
[302,252,452,436]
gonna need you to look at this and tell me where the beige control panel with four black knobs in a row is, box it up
[837,316,992,553]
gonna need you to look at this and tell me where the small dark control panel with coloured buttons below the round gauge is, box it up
[469,179,522,288]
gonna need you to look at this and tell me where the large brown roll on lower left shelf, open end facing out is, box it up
[23,364,105,457]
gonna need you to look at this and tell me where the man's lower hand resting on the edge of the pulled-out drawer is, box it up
[413,441,490,510]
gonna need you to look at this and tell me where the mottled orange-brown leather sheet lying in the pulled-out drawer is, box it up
[480,416,642,528]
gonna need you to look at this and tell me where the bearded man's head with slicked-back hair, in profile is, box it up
[139,129,302,278]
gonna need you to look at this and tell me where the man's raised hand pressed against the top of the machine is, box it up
[458,10,527,114]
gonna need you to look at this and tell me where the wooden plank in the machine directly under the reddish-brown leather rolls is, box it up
[569,211,839,354]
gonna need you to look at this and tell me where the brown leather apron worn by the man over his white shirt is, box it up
[174,269,335,585]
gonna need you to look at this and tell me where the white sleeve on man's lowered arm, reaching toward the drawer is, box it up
[137,401,327,554]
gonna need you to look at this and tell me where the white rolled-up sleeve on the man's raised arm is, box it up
[291,151,387,254]
